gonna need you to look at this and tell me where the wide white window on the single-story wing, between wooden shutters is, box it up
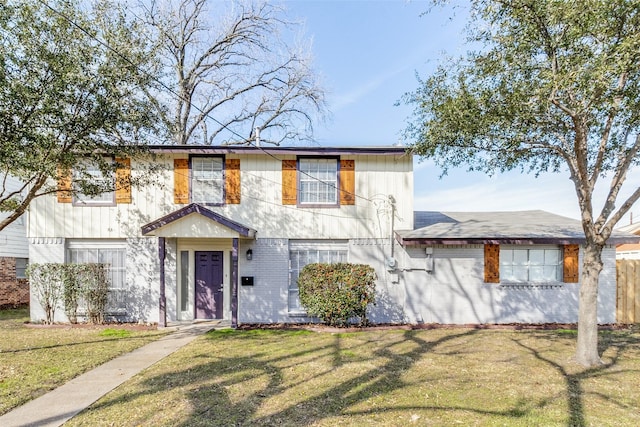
[500,246,562,283]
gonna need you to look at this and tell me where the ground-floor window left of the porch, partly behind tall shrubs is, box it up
[67,242,129,314]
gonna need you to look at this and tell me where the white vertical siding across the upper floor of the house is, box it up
[28,155,413,239]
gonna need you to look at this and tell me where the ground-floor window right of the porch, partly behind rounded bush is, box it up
[288,241,348,314]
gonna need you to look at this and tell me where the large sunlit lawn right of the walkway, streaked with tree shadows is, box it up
[65,328,640,426]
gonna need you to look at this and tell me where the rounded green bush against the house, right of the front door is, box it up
[298,263,376,326]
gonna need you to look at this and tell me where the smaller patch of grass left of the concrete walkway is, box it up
[0,309,168,414]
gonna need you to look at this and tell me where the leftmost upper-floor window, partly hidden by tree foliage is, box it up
[73,158,115,205]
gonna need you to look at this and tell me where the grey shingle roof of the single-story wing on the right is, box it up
[396,210,640,246]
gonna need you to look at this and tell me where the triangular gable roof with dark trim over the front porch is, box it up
[142,203,257,239]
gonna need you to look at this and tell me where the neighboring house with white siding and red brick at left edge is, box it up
[0,176,29,307]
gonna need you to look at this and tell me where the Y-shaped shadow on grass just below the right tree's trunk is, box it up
[512,331,640,427]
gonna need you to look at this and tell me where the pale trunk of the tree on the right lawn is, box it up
[576,242,603,367]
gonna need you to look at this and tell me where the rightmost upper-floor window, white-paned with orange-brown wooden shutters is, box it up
[299,158,338,205]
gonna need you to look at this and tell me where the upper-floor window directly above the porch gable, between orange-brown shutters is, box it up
[191,157,224,204]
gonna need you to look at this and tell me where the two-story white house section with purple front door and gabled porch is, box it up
[28,146,413,325]
